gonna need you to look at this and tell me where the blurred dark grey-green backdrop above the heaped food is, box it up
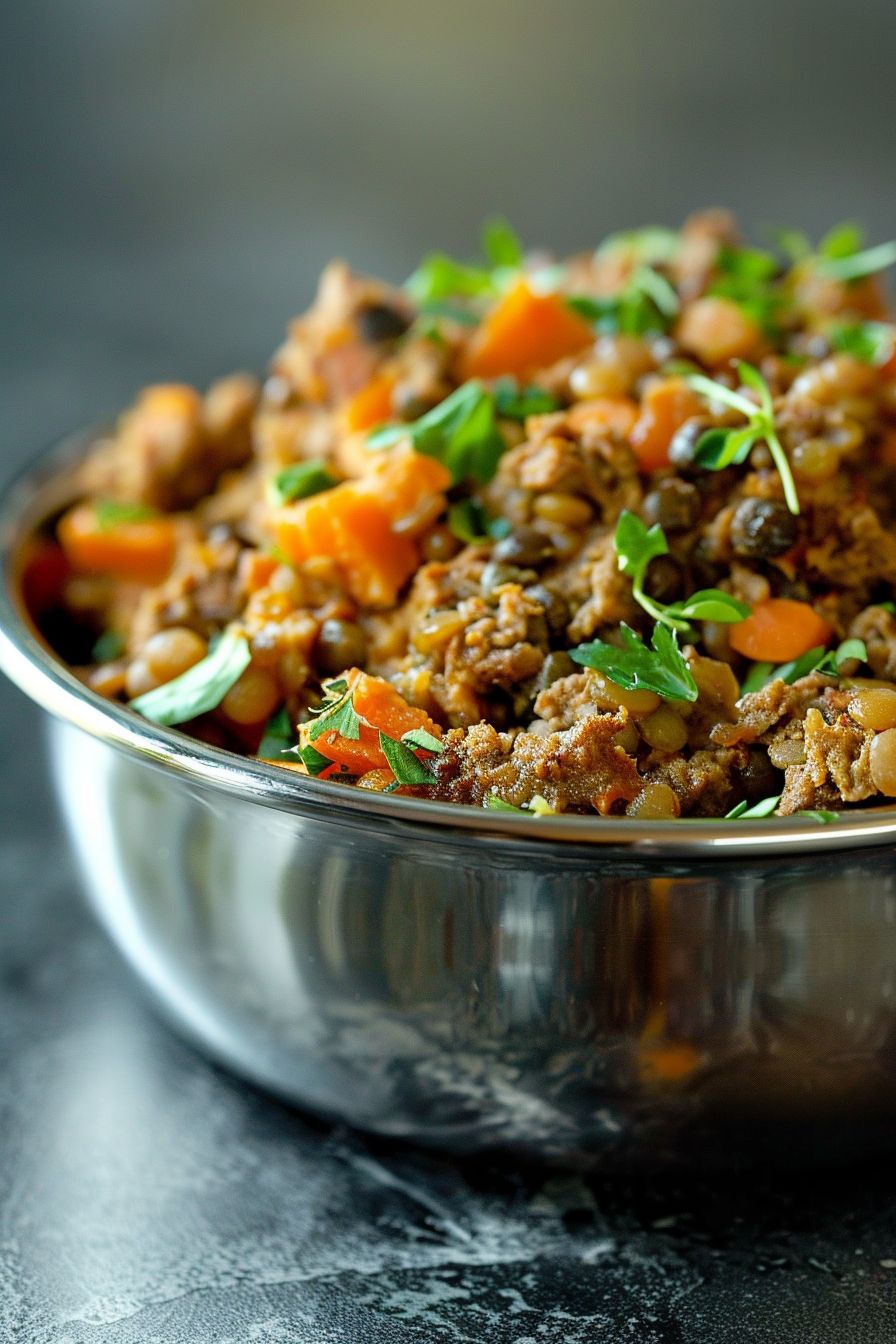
[0,0,896,461]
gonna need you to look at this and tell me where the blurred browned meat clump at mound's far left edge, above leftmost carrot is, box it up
[81,374,258,511]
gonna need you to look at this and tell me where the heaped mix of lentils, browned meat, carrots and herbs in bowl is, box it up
[24,211,896,824]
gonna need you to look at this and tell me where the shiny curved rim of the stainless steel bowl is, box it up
[0,427,896,859]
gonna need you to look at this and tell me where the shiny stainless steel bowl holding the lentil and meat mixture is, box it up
[0,439,896,1164]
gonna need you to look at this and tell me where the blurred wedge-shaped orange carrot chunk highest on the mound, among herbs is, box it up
[461,280,594,379]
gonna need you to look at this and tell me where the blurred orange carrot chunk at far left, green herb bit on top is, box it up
[58,504,177,583]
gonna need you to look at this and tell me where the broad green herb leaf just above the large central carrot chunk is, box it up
[367,380,506,485]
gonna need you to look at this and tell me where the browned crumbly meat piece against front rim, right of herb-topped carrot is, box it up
[435,714,641,812]
